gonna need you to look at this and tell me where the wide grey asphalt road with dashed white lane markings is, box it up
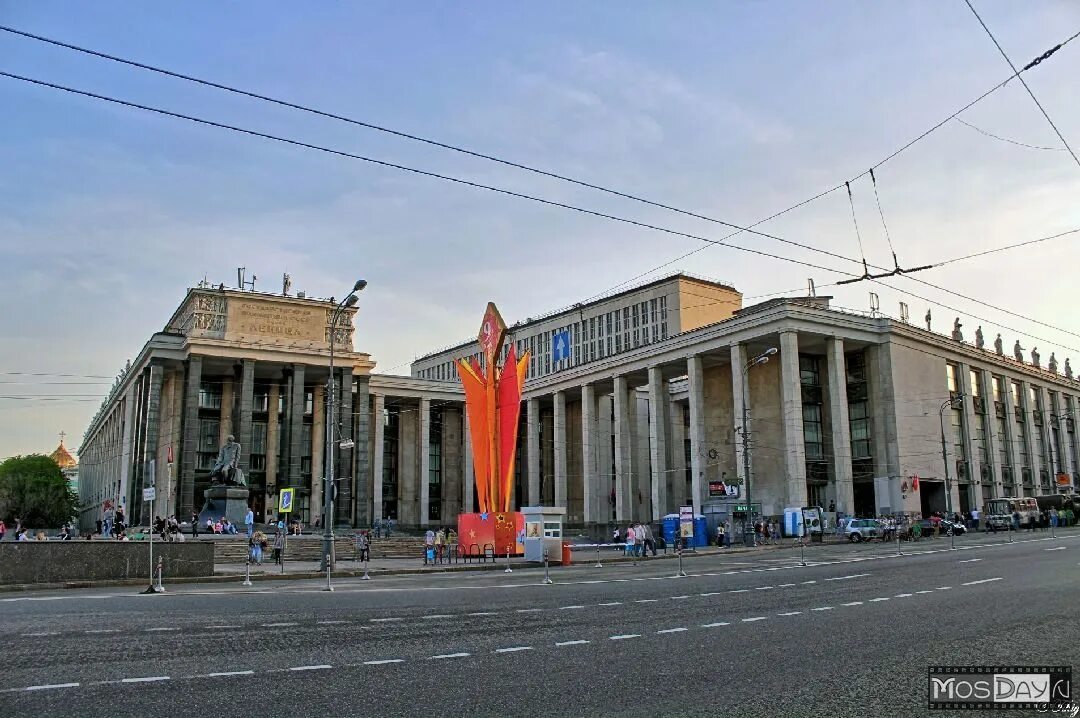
[0,533,1080,718]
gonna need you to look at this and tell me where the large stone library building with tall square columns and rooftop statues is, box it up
[81,274,1080,528]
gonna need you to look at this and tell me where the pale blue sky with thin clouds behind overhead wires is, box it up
[0,0,1080,457]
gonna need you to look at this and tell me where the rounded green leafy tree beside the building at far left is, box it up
[0,453,79,528]
